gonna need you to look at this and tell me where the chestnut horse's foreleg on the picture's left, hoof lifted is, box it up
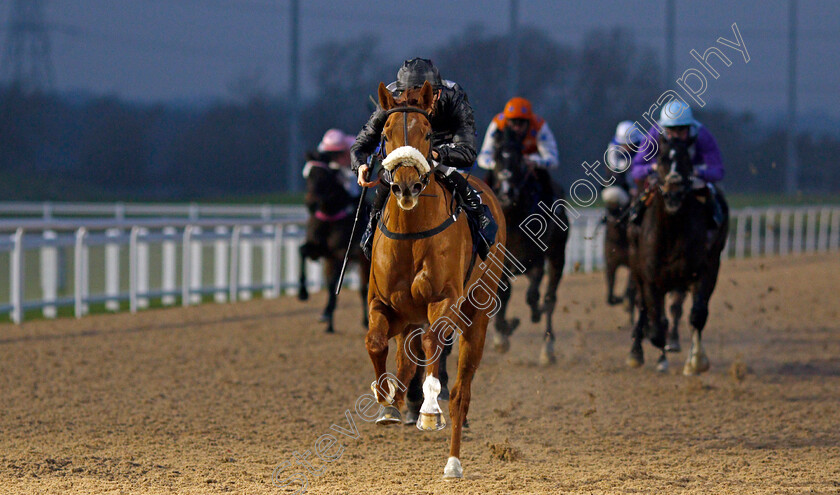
[365,299,404,425]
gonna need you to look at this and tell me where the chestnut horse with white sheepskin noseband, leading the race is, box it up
[365,82,505,478]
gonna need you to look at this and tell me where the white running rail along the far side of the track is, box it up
[0,203,840,323]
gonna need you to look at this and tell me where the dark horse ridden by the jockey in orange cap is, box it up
[487,128,569,365]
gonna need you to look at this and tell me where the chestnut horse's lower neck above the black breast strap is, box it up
[384,176,457,233]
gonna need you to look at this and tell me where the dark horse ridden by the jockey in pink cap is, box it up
[298,155,370,333]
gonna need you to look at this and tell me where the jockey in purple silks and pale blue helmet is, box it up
[630,100,724,226]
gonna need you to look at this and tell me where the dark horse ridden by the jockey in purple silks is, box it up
[627,136,729,375]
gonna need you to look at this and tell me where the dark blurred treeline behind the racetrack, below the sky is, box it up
[0,27,840,200]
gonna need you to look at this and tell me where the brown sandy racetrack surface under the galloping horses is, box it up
[0,253,840,494]
